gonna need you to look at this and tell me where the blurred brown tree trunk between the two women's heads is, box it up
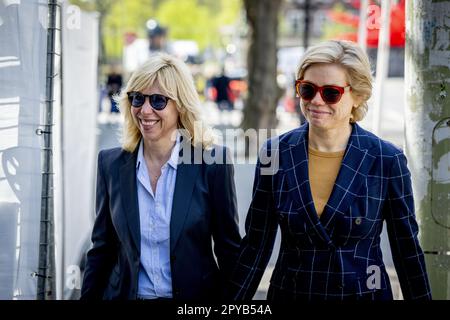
[241,0,282,130]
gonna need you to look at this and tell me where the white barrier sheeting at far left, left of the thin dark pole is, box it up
[0,0,48,299]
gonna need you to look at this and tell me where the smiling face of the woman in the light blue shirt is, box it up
[131,83,178,143]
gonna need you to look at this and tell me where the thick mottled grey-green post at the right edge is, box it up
[405,0,450,300]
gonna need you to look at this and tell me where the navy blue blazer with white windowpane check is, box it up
[227,124,431,301]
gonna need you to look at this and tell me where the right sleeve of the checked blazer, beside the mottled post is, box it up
[383,153,431,300]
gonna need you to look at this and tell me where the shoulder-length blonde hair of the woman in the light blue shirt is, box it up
[115,53,214,152]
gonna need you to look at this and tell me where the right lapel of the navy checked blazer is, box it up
[320,124,375,235]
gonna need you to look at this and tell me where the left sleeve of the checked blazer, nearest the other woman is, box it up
[226,145,278,301]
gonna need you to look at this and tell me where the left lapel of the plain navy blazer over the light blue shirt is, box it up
[119,147,141,254]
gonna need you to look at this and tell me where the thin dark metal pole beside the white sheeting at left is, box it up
[36,0,58,300]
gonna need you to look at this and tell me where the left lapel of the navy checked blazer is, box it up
[281,124,331,245]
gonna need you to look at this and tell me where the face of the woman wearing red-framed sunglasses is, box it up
[301,63,356,130]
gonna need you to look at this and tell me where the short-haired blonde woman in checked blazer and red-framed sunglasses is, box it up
[228,41,431,302]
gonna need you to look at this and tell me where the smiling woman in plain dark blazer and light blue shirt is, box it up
[81,53,241,301]
